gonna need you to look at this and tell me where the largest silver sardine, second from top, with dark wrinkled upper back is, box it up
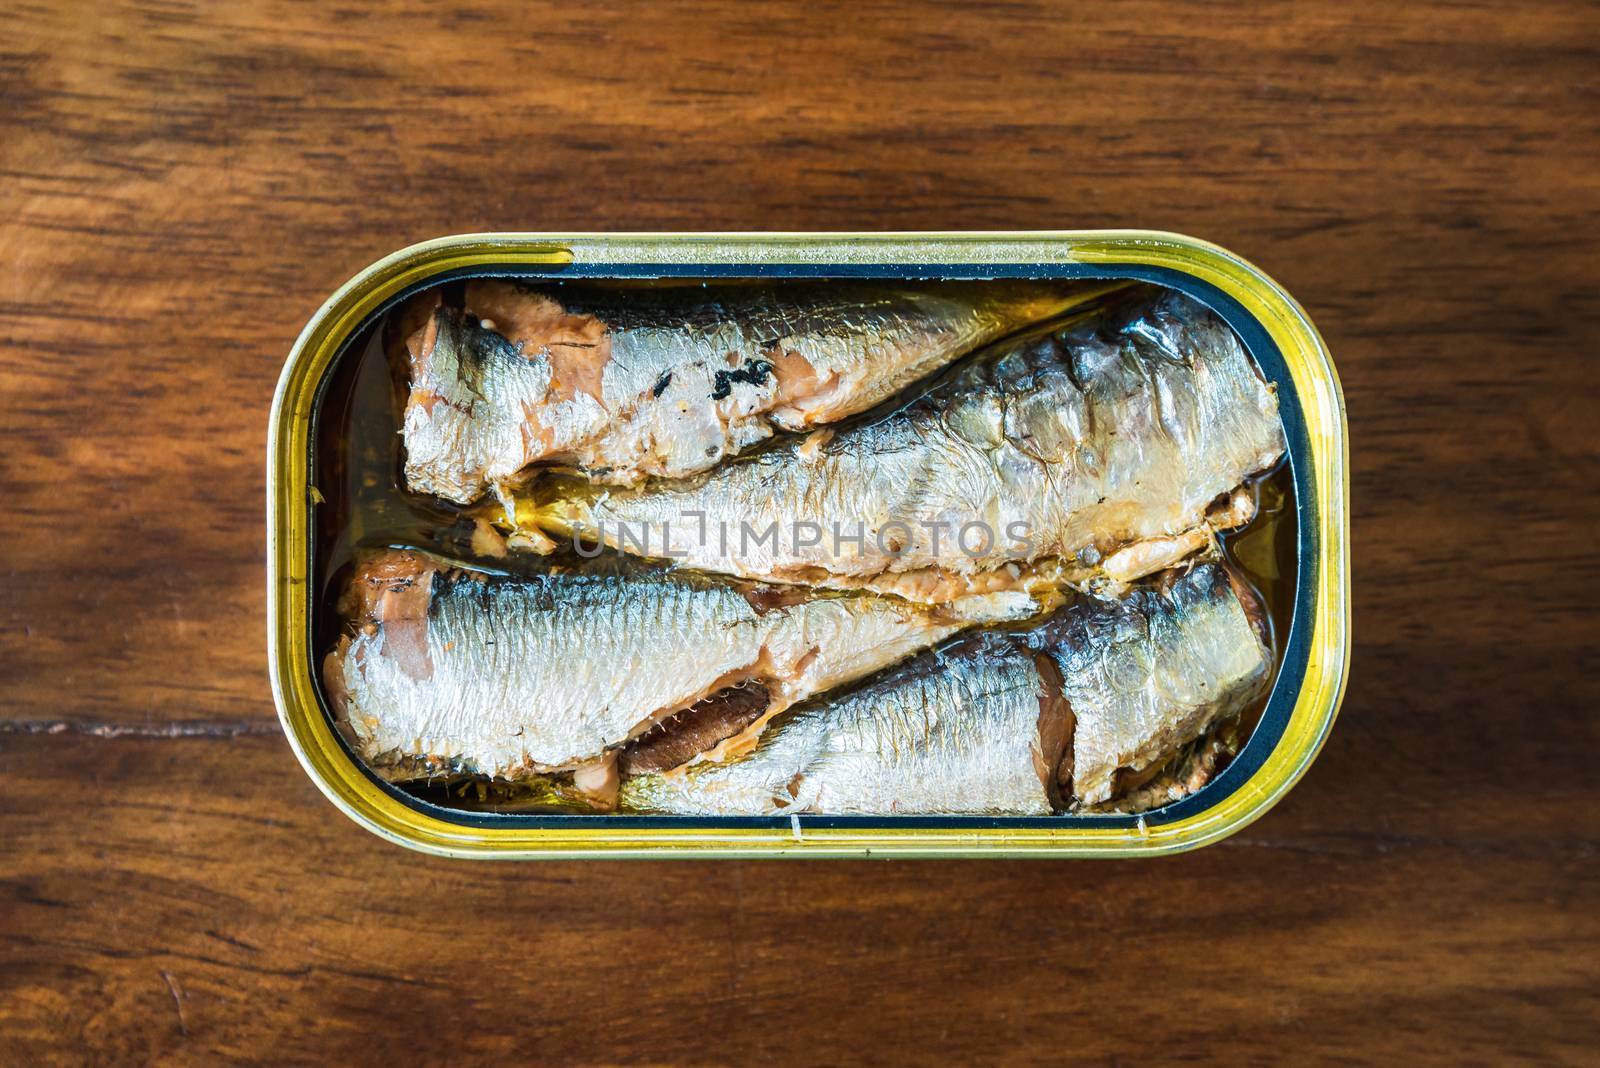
[524,291,1285,603]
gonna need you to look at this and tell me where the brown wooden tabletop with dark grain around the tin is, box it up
[0,0,1600,1065]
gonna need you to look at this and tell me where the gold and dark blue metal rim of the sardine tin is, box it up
[267,230,1350,859]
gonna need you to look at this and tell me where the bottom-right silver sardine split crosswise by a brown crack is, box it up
[621,564,1270,815]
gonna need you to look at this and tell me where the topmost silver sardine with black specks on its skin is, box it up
[402,280,1107,504]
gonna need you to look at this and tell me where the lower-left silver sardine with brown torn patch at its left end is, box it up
[323,550,960,779]
